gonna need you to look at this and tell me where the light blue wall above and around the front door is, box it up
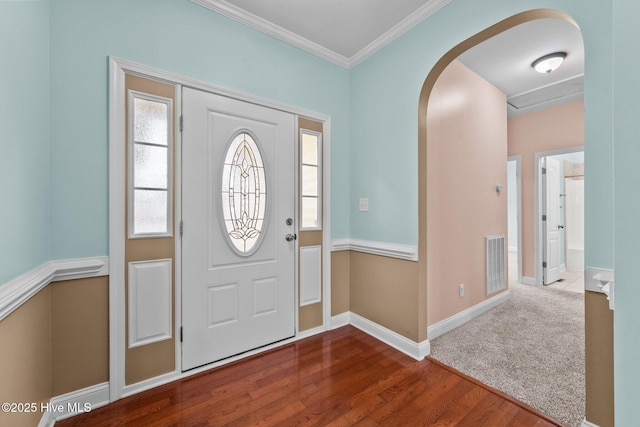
[51,0,349,258]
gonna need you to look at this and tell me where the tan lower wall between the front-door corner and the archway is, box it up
[349,251,420,342]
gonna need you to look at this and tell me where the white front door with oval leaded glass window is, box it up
[182,88,296,370]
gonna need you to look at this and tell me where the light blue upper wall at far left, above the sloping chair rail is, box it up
[0,1,49,285]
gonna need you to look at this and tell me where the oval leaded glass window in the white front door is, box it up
[222,132,267,255]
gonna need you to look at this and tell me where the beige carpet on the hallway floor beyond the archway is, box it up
[431,283,585,426]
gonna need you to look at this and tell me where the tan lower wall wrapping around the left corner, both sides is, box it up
[0,277,109,426]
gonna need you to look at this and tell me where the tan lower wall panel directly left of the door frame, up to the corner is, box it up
[49,277,109,396]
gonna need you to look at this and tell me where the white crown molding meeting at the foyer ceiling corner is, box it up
[191,0,451,69]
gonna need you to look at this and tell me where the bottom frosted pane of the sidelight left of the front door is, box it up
[133,190,168,234]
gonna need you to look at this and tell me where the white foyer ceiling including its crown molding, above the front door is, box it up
[191,0,451,68]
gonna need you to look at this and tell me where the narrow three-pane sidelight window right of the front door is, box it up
[300,130,322,230]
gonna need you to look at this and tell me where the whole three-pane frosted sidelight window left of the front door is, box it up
[128,91,172,238]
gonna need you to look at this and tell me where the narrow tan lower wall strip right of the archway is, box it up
[584,291,614,427]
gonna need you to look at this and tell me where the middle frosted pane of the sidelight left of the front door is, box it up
[133,144,168,189]
